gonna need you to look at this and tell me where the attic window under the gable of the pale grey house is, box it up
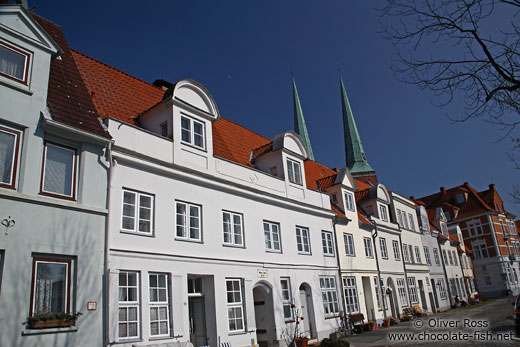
[0,41,30,84]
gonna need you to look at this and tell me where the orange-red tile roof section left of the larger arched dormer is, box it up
[72,50,164,124]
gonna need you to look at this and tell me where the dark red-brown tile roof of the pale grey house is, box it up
[31,13,110,138]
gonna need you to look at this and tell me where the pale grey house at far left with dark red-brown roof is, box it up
[0,4,111,347]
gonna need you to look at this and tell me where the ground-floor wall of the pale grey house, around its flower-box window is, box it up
[0,202,106,347]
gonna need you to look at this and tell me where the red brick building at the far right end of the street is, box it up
[418,182,520,297]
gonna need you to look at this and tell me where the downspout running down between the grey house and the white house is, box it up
[103,142,115,346]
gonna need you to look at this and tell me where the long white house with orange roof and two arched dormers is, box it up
[71,52,341,346]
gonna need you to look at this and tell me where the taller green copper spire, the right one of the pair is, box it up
[339,76,375,174]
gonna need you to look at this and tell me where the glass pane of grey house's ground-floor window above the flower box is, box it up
[34,262,68,313]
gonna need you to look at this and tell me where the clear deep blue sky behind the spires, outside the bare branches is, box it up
[33,0,520,214]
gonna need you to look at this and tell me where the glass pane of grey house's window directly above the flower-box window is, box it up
[43,145,74,196]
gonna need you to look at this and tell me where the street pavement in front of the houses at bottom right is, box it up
[345,297,520,347]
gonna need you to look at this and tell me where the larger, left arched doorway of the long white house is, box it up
[253,281,277,347]
